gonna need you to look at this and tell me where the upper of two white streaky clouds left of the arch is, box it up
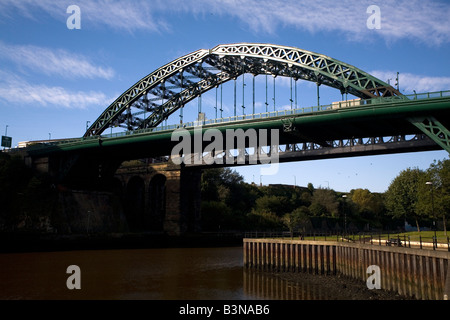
[0,41,114,79]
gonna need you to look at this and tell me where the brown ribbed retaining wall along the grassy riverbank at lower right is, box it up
[244,239,450,300]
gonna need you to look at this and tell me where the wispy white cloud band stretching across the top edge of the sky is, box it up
[0,0,450,45]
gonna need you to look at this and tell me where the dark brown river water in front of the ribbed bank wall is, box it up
[0,247,334,300]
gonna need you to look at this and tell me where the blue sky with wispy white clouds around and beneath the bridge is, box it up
[0,0,450,192]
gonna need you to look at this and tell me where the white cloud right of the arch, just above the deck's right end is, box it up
[369,70,450,94]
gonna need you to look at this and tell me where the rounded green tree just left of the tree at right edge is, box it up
[386,168,427,232]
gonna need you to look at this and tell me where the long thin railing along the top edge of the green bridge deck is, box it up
[49,90,450,144]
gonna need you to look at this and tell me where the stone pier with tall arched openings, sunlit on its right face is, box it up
[114,161,201,235]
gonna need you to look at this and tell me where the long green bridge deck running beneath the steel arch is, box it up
[17,91,450,161]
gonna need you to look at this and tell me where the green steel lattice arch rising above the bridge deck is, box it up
[84,43,401,137]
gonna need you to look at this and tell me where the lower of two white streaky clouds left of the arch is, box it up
[0,71,113,109]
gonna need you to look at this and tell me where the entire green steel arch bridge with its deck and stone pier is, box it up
[12,43,450,233]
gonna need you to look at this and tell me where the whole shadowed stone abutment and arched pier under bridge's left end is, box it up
[20,152,202,236]
